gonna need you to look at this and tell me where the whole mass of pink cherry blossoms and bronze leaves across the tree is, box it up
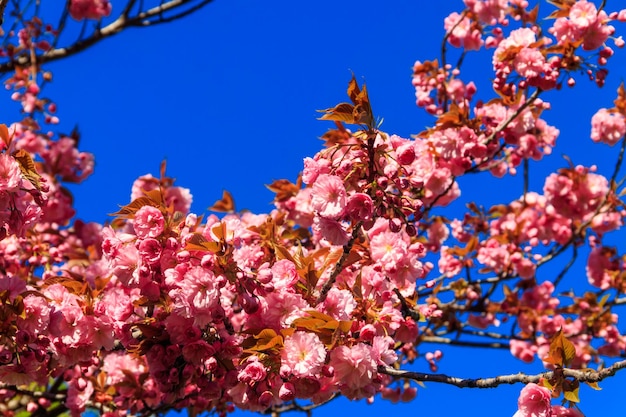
[0,0,626,417]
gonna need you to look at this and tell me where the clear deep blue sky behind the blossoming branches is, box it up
[20,0,626,417]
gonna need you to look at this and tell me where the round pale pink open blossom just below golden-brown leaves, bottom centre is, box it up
[281,331,326,378]
